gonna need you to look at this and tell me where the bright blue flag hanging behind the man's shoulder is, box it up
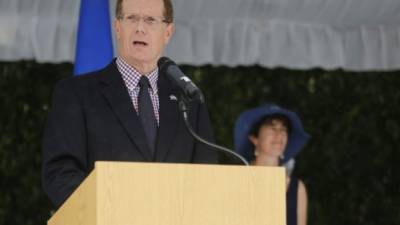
[74,0,113,75]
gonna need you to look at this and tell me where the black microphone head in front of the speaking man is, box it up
[157,57,204,103]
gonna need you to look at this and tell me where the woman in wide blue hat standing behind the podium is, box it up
[235,104,309,225]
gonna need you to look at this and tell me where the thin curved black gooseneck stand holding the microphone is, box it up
[179,95,249,166]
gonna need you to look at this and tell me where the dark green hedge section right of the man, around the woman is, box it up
[184,67,400,224]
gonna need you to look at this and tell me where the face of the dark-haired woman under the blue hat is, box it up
[249,119,288,157]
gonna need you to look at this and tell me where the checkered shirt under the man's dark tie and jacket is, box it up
[116,57,160,125]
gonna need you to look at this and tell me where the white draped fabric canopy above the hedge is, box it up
[0,0,400,71]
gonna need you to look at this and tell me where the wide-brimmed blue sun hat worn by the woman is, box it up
[234,103,310,164]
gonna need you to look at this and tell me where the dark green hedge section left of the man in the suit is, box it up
[0,62,72,224]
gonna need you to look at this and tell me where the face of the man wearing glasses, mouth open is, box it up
[114,0,173,67]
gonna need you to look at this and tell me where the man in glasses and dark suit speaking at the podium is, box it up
[42,0,217,207]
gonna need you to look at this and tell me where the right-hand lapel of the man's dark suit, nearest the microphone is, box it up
[155,74,179,162]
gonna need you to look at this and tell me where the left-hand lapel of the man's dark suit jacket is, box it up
[100,60,152,161]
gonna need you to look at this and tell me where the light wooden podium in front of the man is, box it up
[48,162,286,225]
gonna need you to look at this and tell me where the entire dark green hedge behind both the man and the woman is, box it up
[0,62,400,225]
